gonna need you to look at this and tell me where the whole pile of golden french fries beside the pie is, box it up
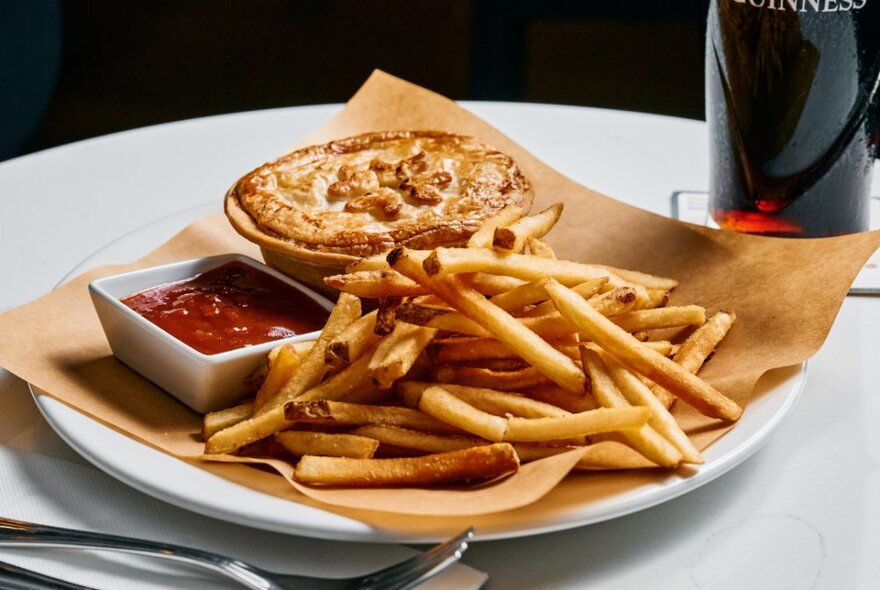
[203,204,742,486]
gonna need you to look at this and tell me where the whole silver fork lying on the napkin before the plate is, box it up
[0,518,474,590]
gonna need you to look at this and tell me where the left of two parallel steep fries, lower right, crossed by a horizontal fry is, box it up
[581,347,687,467]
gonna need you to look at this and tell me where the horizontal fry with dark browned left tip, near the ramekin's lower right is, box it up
[284,400,461,434]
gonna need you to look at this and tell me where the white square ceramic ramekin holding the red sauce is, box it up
[89,254,333,413]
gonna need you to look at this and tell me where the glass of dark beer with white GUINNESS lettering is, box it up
[706,0,880,237]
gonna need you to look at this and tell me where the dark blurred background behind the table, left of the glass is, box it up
[0,0,708,159]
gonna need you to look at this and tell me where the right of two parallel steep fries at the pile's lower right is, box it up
[600,349,703,464]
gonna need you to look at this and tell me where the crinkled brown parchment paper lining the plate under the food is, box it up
[0,72,880,526]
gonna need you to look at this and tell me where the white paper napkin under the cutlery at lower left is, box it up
[0,369,487,590]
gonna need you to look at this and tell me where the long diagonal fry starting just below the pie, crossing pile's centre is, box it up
[388,248,585,391]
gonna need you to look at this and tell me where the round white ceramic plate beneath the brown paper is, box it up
[34,203,806,542]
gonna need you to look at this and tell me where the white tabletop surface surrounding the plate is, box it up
[0,103,880,590]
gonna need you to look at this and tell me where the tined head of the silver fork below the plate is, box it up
[360,527,474,589]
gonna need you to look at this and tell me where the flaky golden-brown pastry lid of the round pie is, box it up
[226,131,532,256]
